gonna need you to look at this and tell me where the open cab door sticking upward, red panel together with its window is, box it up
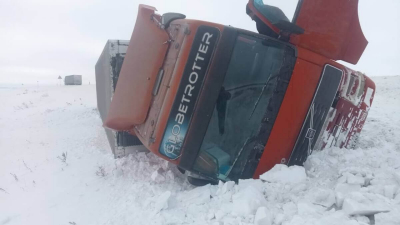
[248,0,368,64]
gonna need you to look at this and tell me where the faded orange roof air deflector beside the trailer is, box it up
[104,5,169,130]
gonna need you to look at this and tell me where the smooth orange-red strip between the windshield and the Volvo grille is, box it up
[254,59,322,178]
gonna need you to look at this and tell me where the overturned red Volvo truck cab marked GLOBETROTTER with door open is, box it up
[96,0,375,184]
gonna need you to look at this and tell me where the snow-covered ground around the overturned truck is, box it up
[0,76,400,225]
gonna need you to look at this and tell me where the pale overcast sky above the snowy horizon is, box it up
[0,0,400,84]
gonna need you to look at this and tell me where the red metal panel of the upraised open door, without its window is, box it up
[290,0,368,64]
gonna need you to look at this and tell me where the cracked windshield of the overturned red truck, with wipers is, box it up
[193,35,285,180]
